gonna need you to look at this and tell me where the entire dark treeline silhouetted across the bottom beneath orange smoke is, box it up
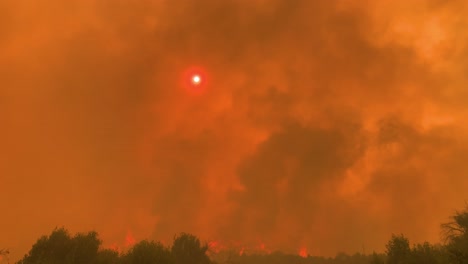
[11,207,468,264]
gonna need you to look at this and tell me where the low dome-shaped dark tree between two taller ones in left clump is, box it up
[123,240,173,264]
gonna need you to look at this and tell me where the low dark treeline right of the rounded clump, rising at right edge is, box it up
[212,204,468,264]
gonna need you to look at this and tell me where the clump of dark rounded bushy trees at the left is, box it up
[17,228,212,264]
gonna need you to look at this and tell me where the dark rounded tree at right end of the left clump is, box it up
[171,233,211,264]
